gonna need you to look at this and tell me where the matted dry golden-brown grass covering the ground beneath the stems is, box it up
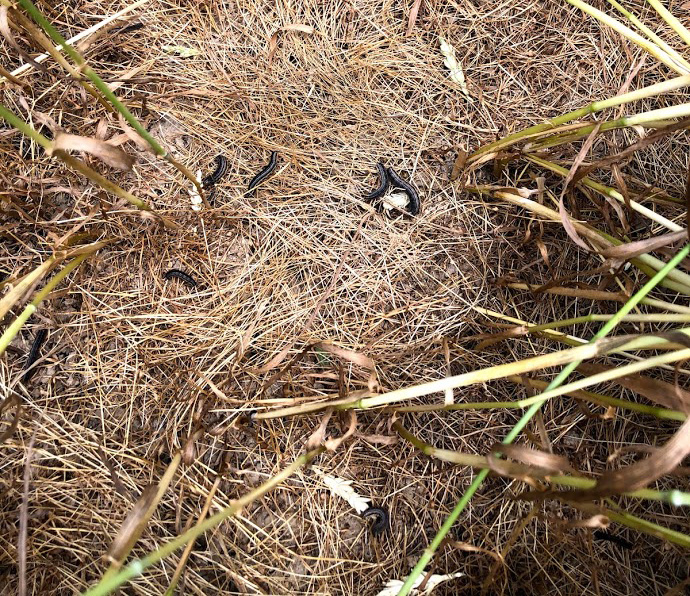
[0,0,688,595]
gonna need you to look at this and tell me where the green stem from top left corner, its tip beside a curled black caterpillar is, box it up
[17,0,203,200]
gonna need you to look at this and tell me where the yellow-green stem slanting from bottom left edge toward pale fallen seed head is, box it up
[84,447,325,596]
